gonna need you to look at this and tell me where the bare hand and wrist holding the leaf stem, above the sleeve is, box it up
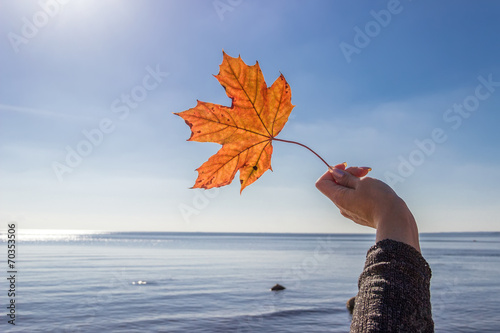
[316,164,420,251]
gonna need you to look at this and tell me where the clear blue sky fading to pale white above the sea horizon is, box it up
[0,0,500,233]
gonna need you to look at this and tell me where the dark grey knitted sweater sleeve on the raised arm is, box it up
[351,239,434,332]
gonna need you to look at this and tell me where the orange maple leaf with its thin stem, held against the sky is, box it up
[174,51,336,193]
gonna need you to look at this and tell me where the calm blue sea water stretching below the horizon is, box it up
[0,232,500,332]
